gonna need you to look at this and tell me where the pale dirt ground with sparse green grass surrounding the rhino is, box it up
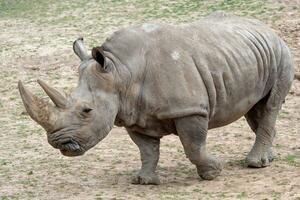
[0,0,300,200]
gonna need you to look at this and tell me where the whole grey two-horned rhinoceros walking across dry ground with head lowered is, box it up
[18,12,294,184]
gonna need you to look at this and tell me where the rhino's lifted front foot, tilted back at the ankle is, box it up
[197,158,222,180]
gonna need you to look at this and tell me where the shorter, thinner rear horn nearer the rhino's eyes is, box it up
[37,79,67,108]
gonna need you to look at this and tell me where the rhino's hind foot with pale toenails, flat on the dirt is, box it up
[246,149,274,168]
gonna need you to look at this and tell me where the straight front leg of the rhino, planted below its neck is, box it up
[128,131,160,185]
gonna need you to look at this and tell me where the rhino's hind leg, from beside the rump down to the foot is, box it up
[245,55,293,167]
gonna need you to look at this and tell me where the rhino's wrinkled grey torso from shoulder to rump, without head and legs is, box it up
[105,14,283,128]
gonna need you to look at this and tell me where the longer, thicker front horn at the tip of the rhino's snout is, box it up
[18,81,57,132]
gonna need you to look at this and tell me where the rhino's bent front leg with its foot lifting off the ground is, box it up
[175,116,222,180]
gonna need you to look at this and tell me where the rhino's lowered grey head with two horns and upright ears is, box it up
[18,38,119,156]
